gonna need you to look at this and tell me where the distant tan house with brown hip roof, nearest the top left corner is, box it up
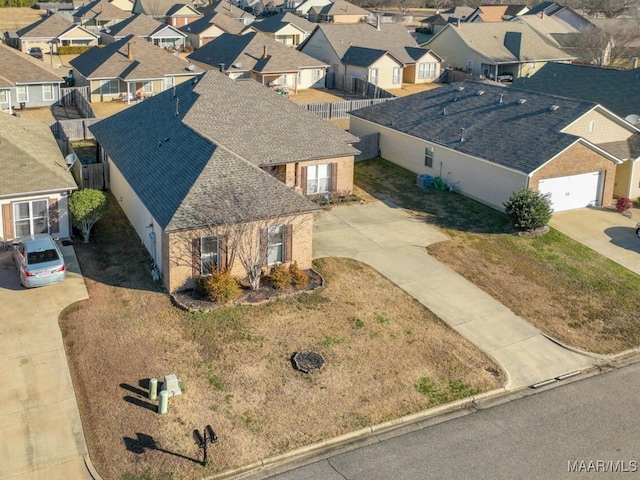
[16,13,98,53]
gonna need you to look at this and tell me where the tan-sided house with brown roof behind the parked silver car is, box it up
[0,111,78,240]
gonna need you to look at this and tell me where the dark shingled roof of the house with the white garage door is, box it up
[350,81,597,174]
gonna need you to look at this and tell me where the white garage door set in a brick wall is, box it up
[538,172,602,212]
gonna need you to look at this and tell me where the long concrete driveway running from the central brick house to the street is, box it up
[313,202,597,389]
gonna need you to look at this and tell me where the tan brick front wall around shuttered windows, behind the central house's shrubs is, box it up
[162,213,313,292]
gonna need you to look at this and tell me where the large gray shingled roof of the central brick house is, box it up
[90,71,357,231]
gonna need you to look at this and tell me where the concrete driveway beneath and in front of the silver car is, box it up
[0,246,92,480]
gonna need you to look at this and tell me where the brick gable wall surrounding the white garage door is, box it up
[529,143,616,206]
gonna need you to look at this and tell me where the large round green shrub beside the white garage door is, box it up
[504,188,552,231]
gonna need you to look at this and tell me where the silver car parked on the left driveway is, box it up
[13,233,67,288]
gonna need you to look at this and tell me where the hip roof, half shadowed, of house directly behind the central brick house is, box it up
[187,32,327,73]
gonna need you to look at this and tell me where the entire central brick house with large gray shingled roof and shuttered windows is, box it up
[90,71,358,292]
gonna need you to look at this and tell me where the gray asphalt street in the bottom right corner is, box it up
[270,363,640,480]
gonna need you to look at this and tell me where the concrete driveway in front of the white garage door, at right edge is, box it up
[549,207,640,275]
